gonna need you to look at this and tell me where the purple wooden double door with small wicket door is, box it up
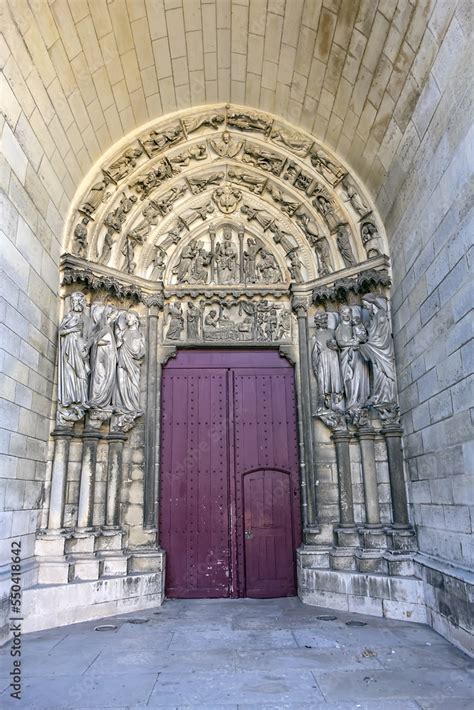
[160,350,301,598]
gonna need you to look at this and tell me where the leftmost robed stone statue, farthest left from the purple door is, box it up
[58,291,90,424]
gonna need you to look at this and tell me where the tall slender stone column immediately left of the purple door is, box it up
[143,298,162,529]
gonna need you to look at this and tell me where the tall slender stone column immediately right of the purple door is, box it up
[293,298,319,545]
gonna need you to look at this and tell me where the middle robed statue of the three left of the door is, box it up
[89,301,117,409]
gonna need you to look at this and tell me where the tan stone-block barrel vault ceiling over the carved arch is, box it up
[0,0,462,221]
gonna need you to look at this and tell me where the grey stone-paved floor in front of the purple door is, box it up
[0,598,474,710]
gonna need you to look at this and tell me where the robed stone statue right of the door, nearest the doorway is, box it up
[312,313,343,409]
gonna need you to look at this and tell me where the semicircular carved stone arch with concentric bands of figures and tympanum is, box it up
[66,106,386,291]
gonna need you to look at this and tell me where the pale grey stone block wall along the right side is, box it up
[378,3,474,652]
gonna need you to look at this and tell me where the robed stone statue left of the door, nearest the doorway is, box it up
[114,311,145,416]
